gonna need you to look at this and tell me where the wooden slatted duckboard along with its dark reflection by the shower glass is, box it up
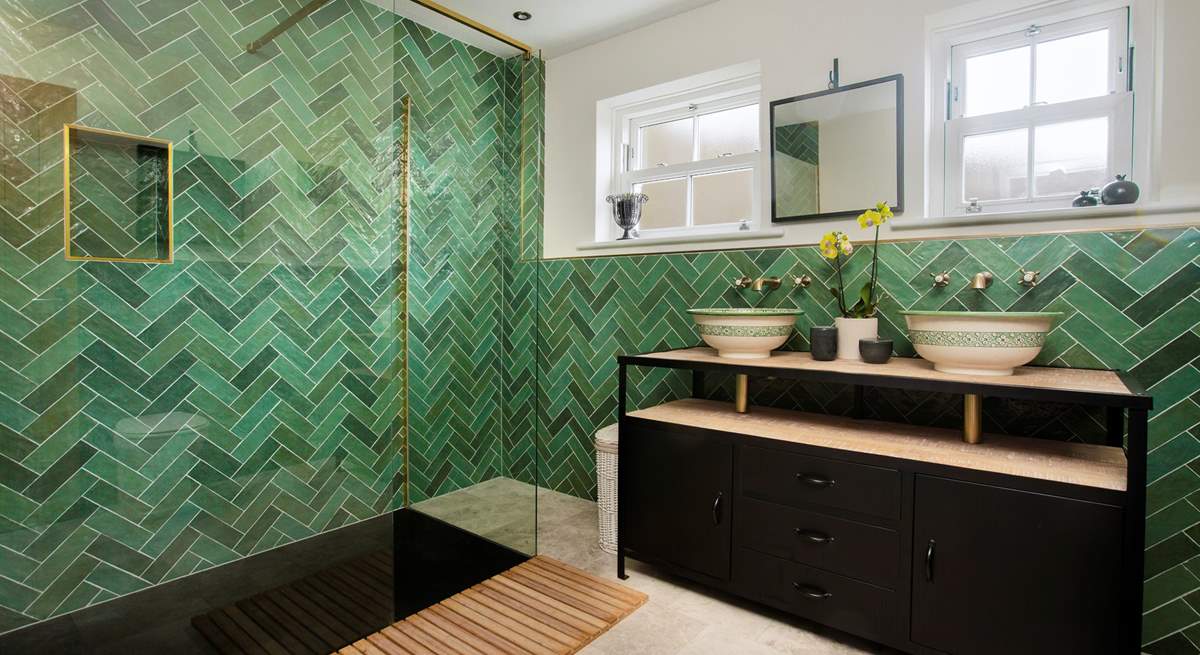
[192,553,648,655]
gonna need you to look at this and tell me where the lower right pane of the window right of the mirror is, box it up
[1033,118,1109,196]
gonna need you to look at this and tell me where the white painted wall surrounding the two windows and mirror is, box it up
[545,0,1200,258]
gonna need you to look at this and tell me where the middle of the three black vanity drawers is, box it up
[737,498,900,587]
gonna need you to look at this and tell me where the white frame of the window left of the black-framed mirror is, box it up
[598,74,762,240]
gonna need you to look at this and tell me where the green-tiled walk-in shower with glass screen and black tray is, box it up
[0,0,544,653]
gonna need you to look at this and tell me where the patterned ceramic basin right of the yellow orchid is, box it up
[900,311,1062,375]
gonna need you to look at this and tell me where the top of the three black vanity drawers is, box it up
[738,446,900,518]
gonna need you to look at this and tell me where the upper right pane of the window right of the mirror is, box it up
[1037,30,1111,104]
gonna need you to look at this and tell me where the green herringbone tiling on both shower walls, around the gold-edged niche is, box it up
[0,0,540,632]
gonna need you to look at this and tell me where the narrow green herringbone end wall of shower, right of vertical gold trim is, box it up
[396,29,540,499]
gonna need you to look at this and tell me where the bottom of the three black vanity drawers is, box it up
[733,548,901,641]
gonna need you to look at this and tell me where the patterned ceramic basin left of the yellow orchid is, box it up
[688,307,804,360]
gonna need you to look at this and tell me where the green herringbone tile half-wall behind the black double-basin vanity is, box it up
[538,228,1200,654]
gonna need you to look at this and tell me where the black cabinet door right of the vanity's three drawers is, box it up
[912,475,1122,655]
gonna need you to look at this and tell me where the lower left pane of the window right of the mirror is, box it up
[962,128,1030,203]
